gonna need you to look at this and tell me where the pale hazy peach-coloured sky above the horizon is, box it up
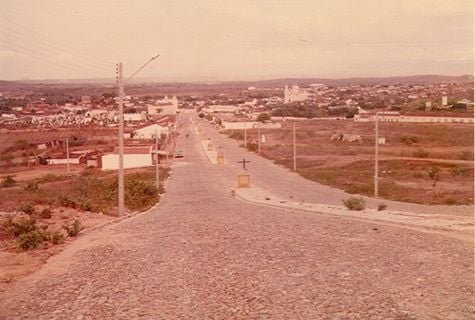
[0,0,474,81]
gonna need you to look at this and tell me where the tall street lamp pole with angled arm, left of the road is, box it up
[117,54,160,216]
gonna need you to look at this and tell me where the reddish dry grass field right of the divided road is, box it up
[229,120,474,204]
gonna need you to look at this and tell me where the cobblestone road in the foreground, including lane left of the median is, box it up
[0,112,475,320]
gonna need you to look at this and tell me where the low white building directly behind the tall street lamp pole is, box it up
[100,146,153,170]
